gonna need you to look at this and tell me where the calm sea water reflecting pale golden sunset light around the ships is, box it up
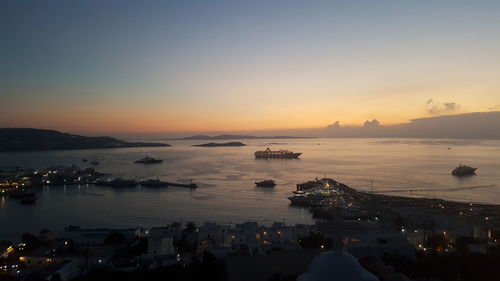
[0,139,500,240]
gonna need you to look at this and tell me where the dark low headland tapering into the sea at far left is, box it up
[0,128,170,151]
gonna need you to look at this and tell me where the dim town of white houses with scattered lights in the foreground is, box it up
[0,208,498,281]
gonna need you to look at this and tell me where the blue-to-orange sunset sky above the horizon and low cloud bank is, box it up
[0,0,500,134]
